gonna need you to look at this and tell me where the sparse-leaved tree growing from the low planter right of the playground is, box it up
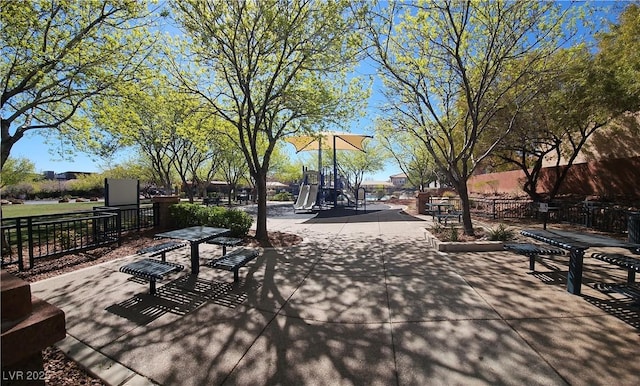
[364,0,572,235]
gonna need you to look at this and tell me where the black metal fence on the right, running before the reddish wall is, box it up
[431,197,634,233]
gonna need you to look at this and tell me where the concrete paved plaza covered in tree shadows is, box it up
[31,204,640,385]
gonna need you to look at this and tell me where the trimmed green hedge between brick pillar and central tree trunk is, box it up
[169,203,253,237]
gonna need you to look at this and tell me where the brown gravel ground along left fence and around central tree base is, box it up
[6,230,302,386]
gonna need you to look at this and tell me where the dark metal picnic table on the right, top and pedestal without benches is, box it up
[520,229,640,295]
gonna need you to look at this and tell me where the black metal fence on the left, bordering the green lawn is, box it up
[0,205,158,270]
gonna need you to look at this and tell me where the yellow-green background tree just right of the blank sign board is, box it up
[91,74,204,195]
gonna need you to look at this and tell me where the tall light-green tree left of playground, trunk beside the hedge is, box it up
[173,0,365,242]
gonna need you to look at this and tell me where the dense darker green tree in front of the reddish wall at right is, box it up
[496,5,640,201]
